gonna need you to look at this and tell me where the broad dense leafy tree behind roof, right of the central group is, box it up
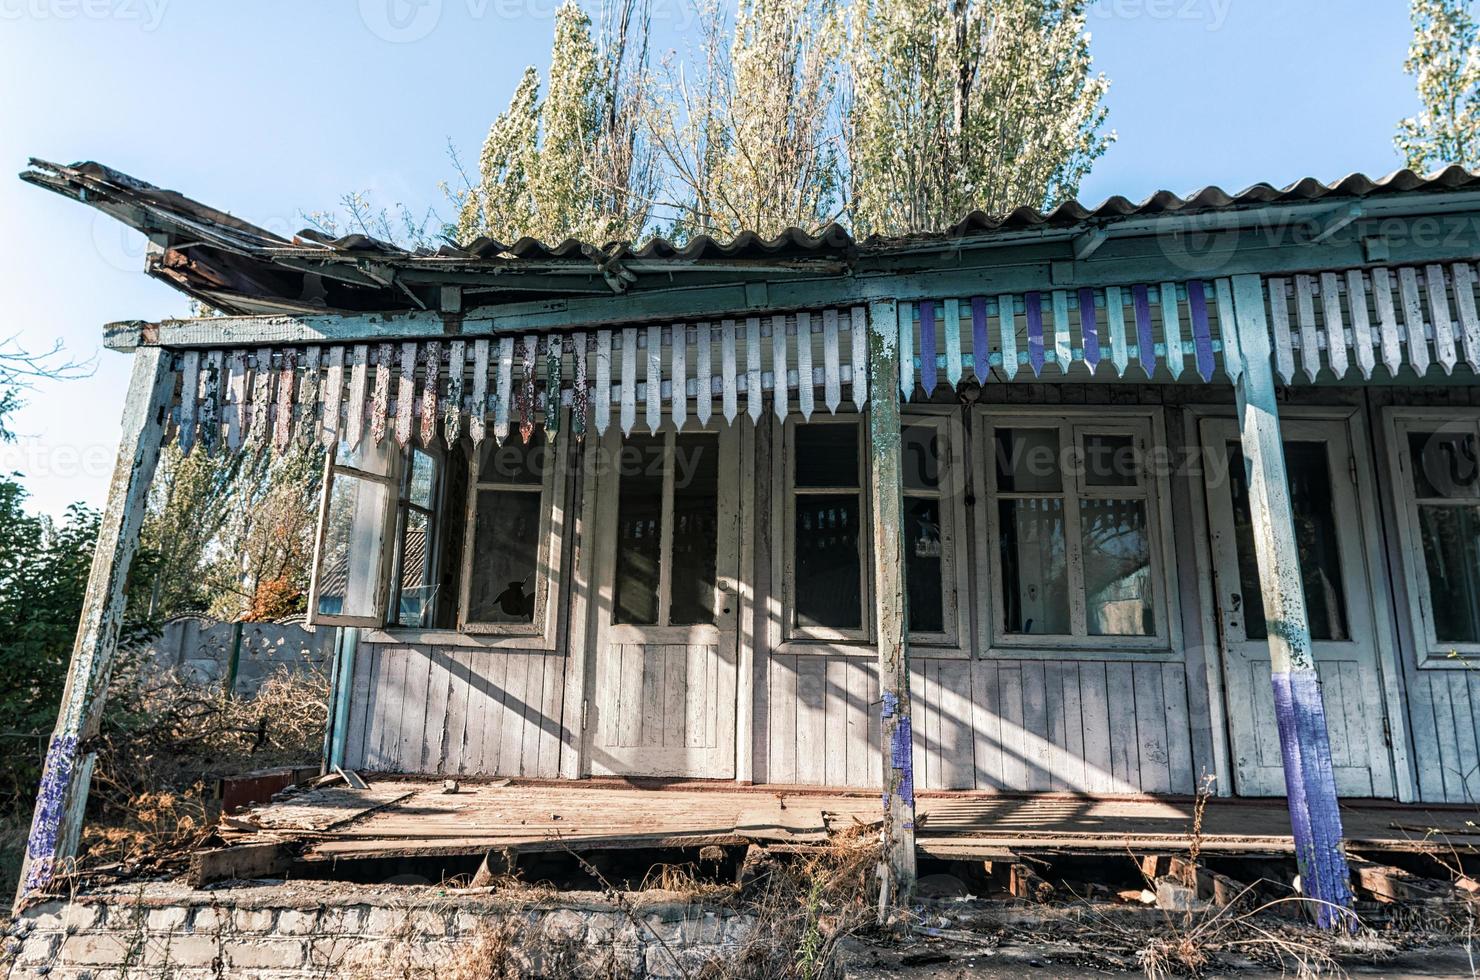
[847,0,1114,234]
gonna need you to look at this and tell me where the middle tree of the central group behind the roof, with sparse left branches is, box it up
[653,0,845,238]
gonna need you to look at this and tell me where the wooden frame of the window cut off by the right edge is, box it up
[1382,406,1480,671]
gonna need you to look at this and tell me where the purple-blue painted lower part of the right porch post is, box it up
[1271,669,1356,928]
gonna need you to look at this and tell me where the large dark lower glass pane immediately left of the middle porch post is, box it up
[795,494,863,629]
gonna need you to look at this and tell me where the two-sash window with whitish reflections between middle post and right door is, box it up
[984,415,1169,648]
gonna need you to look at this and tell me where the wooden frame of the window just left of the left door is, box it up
[452,410,573,650]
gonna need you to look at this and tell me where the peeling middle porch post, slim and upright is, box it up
[869,301,915,919]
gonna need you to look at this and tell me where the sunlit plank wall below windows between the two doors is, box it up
[758,654,1196,793]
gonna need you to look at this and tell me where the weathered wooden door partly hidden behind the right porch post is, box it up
[1202,419,1393,798]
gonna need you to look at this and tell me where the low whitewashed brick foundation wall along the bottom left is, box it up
[0,882,753,980]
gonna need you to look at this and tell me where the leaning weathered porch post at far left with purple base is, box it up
[16,346,175,907]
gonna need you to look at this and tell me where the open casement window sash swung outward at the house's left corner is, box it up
[308,440,397,626]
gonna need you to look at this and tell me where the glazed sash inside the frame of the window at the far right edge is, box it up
[1393,409,1480,666]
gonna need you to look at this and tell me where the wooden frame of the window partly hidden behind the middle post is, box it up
[771,404,971,657]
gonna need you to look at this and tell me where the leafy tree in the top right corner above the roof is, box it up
[1393,0,1480,173]
